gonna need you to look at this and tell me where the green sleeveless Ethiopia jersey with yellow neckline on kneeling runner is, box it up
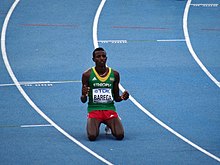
[88,67,116,112]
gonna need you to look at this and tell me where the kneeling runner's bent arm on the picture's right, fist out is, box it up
[113,71,129,102]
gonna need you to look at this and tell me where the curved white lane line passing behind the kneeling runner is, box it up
[93,0,220,162]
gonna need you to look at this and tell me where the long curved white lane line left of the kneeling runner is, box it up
[1,0,112,165]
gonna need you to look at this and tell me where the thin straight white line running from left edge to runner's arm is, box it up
[0,80,81,87]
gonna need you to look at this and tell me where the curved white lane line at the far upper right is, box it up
[183,0,220,88]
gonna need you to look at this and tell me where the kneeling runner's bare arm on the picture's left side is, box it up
[80,70,91,103]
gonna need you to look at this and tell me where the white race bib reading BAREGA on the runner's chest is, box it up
[92,88,113,103]
